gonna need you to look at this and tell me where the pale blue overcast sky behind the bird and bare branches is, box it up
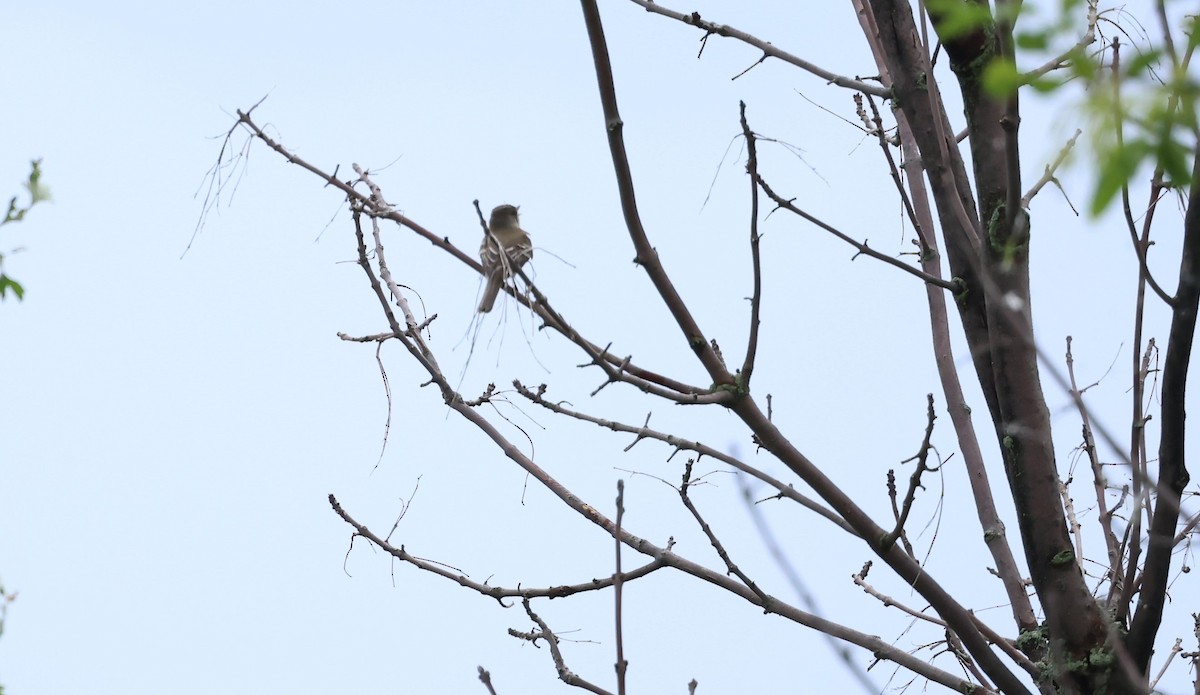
[0,0,1198,695]
